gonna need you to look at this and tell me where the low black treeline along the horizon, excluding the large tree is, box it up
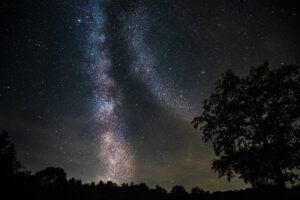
[0,131,300,200]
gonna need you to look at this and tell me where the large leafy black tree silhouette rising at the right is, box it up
[192,62,300,187]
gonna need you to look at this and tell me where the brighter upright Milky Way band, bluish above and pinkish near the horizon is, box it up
[86,1,134,183]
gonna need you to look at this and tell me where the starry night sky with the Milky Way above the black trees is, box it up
[0,0,300,191]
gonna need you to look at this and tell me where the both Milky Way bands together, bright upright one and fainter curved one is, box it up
[86,1,193,183]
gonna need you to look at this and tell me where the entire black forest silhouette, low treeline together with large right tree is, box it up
[0,63,300,200]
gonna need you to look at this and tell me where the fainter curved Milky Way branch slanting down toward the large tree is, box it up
[124,8,195,119]
